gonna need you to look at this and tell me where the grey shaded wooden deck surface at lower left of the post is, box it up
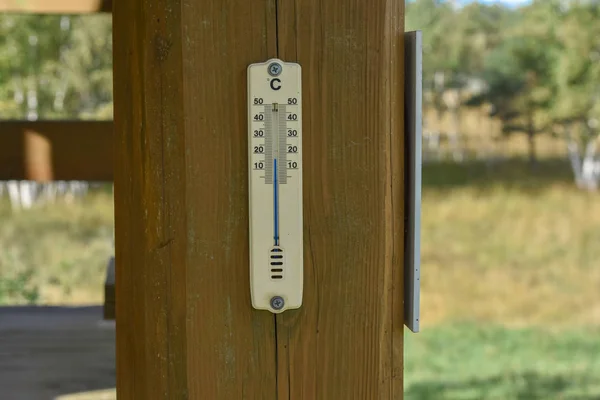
[0,307,115,400]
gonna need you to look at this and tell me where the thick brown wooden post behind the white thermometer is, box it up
[113,0,404,400]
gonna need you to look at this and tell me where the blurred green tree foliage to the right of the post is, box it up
[406,0,600,161]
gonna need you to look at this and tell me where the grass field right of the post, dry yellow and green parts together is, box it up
[405,160,600,400]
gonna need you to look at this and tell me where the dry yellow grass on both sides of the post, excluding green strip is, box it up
[0,161,600,328]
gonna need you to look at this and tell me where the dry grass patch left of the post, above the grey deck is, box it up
[0,191,113,304]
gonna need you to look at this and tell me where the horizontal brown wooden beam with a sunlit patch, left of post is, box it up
[0,121,113,182]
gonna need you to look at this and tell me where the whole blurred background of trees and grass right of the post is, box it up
[405,0,600,399]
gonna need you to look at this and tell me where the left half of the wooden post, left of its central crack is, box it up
[113,0,276,400]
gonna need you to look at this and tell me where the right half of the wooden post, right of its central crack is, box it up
[277,0,404,400]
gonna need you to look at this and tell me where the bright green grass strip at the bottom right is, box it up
[404,324,600,400]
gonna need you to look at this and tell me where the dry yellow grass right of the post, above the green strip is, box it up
[422,159,600,326]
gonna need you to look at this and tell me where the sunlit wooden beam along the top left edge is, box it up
[0,0,112,14]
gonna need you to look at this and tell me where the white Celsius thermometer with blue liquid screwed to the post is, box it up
[248,59,303,313]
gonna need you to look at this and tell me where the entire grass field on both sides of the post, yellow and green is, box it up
[0,159,600,400]
